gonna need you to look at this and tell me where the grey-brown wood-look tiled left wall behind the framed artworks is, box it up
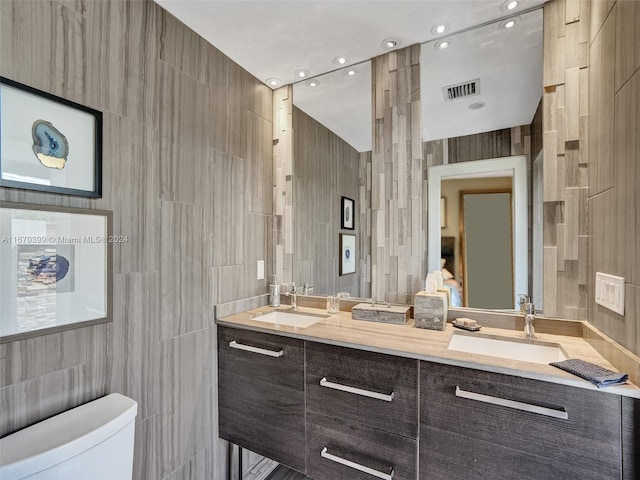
[0,0,276,480]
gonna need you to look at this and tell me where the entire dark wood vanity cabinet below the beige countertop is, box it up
[218,326,640,480]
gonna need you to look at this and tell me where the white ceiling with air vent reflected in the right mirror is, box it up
[420,9,542,141]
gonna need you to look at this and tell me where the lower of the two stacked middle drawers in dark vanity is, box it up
[307,412,417,480]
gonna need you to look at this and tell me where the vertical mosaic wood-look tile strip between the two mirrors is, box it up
[371,45,426,301]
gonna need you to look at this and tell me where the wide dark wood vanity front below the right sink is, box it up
[419,362,621,480]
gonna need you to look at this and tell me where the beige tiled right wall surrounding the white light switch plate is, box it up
[580,0,640,355]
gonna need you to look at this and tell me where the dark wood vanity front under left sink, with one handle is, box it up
[218,327,305,472]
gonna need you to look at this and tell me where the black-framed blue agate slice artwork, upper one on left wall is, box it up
[0,77,102,198]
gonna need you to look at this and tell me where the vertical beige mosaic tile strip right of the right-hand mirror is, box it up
[543,0,592,319]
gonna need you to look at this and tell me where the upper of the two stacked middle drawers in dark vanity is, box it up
[306,342,418,438]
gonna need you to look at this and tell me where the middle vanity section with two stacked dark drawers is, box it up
[306,342,418,480]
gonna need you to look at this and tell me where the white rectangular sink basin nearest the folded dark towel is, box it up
[447,333,568,364]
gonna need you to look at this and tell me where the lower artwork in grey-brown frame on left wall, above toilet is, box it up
[0,202,112,343]
